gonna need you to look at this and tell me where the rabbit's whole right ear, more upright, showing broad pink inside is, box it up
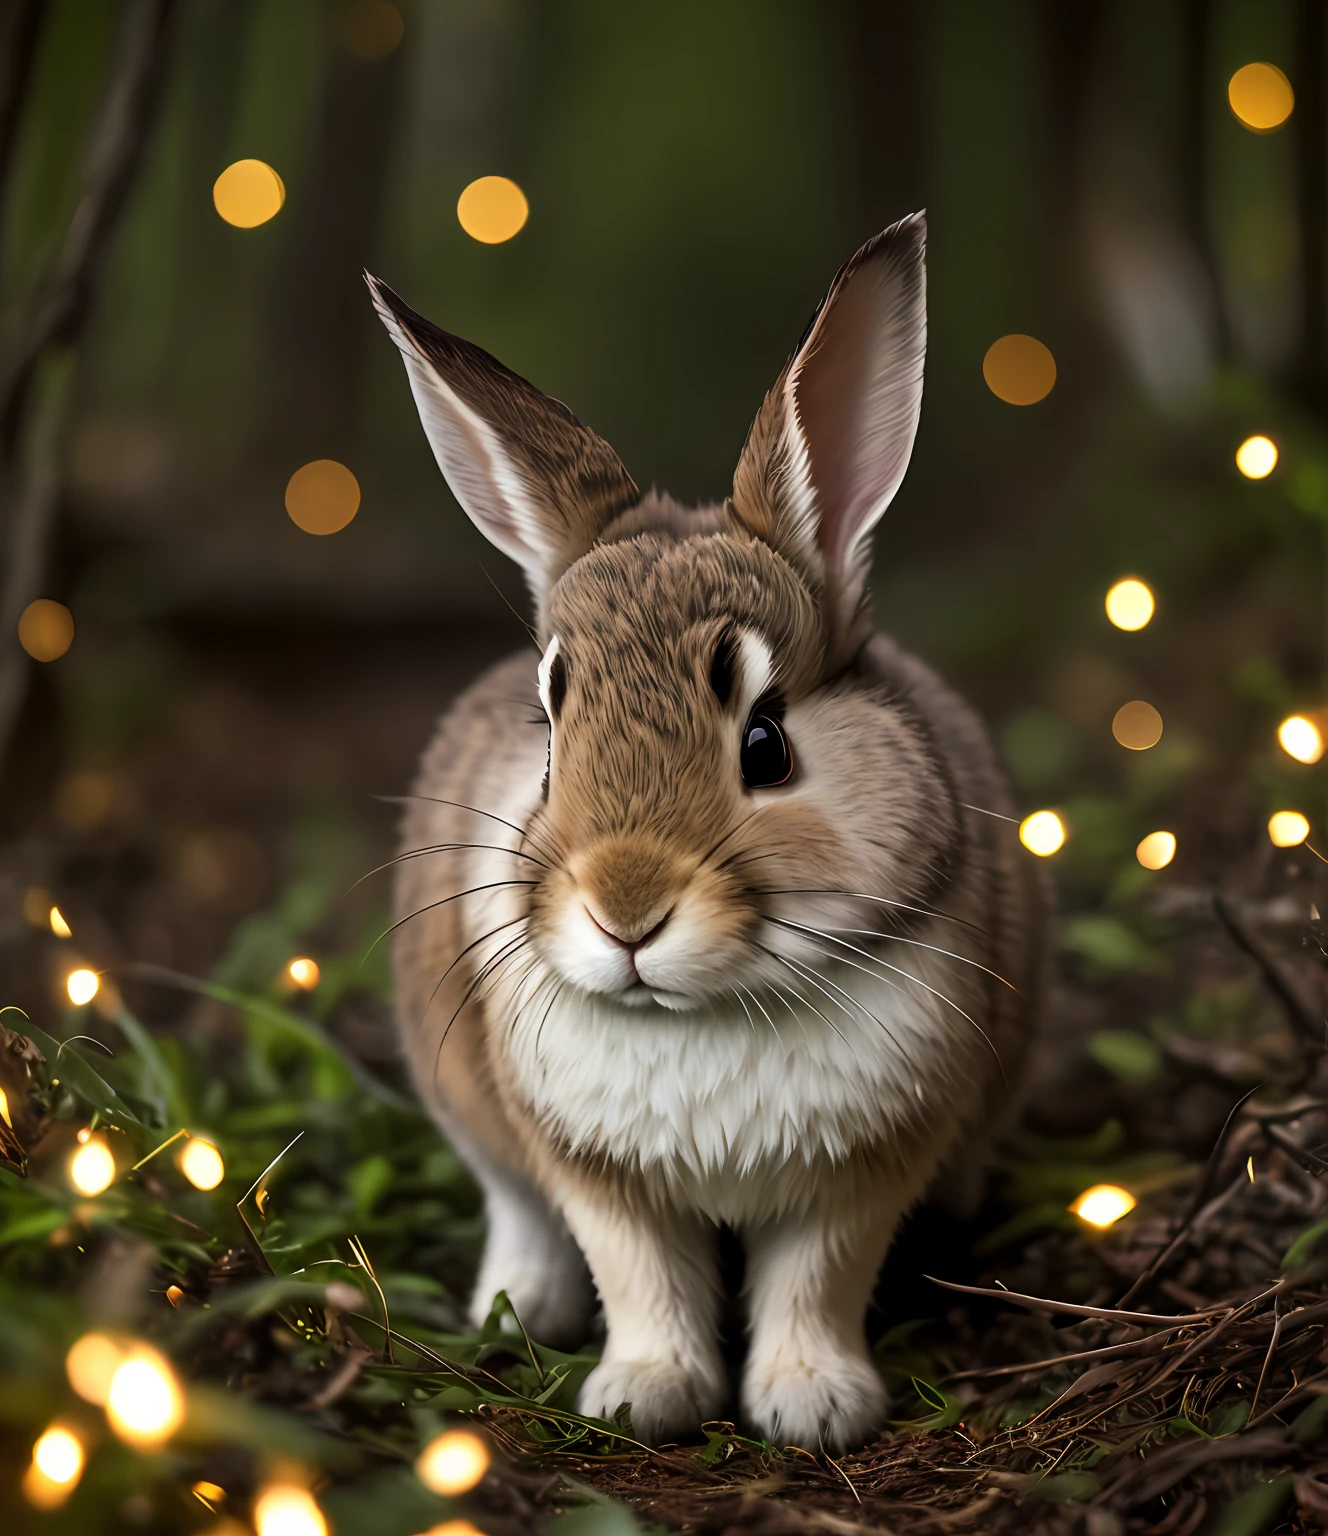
[732,214,927,650]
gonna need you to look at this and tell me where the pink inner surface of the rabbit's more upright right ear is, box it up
[794,260,924,570]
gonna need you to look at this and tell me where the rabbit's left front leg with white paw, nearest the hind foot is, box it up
[563,1190,725,1444]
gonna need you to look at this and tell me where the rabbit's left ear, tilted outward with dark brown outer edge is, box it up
[365,273,640,607]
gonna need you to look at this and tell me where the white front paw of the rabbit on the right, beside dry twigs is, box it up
[743,1355,886,1455]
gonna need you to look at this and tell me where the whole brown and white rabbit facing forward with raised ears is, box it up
[365,214,1047,1452]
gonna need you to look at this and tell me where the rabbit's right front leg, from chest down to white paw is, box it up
[743,1206,901,1452]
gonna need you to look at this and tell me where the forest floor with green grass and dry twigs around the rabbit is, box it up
[0,617,1328,1536]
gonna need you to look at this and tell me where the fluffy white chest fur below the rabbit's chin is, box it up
[493,965,967,1221]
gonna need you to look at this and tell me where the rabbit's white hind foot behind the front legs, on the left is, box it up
[465,1146,594,1349]
